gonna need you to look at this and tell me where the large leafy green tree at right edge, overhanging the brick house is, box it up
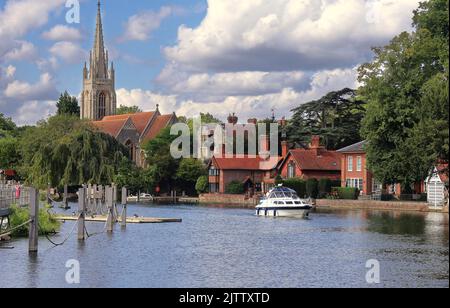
[359,0,449,191]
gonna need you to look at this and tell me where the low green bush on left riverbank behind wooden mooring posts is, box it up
[10,205,61,237]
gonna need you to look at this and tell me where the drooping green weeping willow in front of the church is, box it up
[20,115,128,187]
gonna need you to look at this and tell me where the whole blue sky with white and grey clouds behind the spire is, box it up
[0,0,419,125]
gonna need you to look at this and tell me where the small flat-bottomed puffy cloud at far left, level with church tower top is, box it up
[4,73,58,101]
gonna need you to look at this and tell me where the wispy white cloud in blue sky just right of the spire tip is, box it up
[119,6,174,42]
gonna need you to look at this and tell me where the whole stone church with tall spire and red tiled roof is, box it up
[80,0,177,167]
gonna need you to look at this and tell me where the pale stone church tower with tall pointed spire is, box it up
[81,0,117,121]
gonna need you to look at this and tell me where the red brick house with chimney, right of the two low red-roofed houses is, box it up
[278,136,341,180]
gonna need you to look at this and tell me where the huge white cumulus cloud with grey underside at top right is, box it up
[165,0,419,71]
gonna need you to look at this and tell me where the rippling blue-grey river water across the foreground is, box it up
[0,205,449,288]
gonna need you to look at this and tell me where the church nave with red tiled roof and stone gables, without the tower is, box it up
[92,105,177,167]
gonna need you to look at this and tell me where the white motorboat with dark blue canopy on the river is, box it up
[256,185,313,218]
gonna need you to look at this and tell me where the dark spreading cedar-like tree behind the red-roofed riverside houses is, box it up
[287,88,365,150]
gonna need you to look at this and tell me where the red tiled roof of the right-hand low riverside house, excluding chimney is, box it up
[281,149,341,171]
